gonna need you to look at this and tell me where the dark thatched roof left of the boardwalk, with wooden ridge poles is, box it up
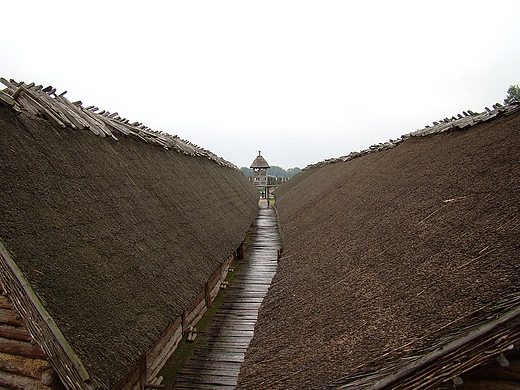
[0,80,258,388]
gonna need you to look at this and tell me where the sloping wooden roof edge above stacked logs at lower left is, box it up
[0,240,91,390]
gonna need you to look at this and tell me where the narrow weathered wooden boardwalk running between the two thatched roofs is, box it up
[173,202,280,389]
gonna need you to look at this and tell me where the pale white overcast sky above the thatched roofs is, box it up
[0,0,520,168]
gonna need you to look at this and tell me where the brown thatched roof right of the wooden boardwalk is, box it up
[238,105,520,389]
